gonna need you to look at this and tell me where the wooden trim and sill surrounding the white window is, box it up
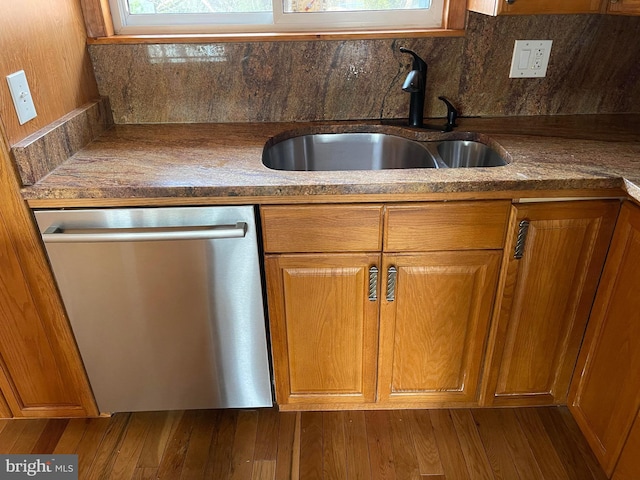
[80,0,467,44]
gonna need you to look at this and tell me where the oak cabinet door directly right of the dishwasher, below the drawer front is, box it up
[265,253,380,409]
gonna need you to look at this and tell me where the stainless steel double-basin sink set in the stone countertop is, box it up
[262,132,508,171]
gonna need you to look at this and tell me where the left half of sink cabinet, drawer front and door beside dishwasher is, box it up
[261,205,383,408]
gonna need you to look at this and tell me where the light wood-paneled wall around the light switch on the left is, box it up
[0,0,98,145]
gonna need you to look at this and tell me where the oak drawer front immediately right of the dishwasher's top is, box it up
[260,205,382,253]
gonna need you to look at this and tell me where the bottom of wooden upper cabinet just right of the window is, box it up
[467,0,604,16]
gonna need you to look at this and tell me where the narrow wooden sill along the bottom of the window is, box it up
[87,29,465,45]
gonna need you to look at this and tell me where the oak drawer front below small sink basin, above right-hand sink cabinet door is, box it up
[384,200,511,252]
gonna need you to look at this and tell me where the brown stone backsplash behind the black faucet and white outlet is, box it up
[89,13,640,123]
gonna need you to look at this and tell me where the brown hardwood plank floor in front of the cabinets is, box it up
[0,407,606,480]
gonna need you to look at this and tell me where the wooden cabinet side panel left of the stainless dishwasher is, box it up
[0,127,98,417]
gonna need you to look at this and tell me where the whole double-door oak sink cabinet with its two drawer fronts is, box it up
[261,201,510,409]
